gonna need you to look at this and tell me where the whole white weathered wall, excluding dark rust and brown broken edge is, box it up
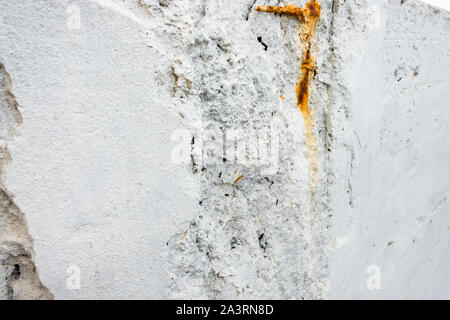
[0,0,450,299]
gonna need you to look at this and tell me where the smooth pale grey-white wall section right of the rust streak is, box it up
[329,1,450,299]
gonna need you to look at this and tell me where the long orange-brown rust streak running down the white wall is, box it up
[256,0,321,192]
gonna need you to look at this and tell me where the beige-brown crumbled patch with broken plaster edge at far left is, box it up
[0,63,53,300]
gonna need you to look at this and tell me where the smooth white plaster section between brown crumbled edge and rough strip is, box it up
[0,0,198,298]
